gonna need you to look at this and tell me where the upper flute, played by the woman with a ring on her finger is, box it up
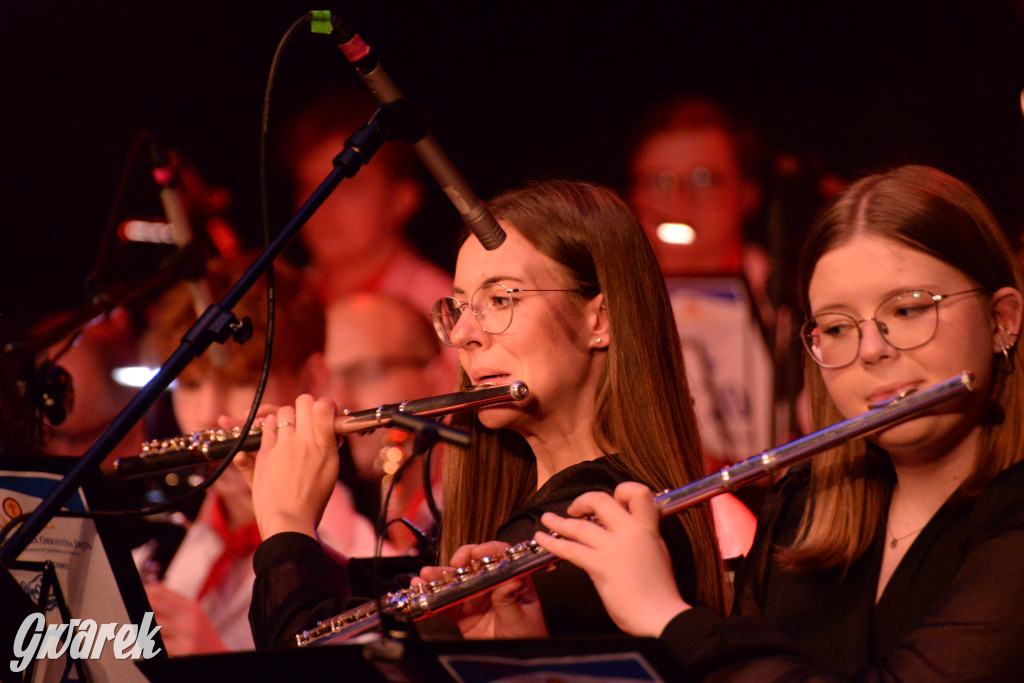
[114,382,529,477]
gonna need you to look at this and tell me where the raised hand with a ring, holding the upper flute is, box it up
[234,394,338,539]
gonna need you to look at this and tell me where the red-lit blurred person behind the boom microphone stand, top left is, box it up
[278,84,452,310]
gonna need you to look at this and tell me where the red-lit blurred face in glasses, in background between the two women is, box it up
[628,128,760,274]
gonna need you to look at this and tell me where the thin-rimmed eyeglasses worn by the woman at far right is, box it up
[800,289,985,368]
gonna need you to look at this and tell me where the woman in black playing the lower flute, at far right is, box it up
[538,166,1024,681]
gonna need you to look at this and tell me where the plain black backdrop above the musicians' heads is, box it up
[0,0,1024,337]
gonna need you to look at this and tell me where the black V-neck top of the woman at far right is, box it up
[662,463,1024,681]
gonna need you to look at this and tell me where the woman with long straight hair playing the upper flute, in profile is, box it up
[237,180,726,646]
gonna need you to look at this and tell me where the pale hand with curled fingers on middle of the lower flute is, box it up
[535,482,689,637]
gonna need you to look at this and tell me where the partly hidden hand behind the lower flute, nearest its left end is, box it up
[414,541,548,640]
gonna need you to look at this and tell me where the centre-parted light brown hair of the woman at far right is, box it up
[780,166,1024,570]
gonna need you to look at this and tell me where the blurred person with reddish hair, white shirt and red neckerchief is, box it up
[136,254,375,655]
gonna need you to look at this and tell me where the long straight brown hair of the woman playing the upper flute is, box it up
[441,180,724,610]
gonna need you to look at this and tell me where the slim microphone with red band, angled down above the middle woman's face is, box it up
[331,15,505,250]
